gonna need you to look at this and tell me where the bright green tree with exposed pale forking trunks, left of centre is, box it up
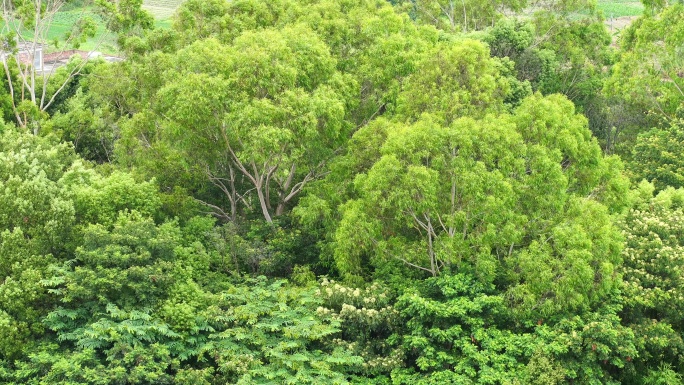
[131,26,355,222]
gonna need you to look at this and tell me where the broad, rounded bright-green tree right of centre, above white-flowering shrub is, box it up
[334,90,627,315]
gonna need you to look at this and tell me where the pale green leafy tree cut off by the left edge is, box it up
[0,126,76,359]
